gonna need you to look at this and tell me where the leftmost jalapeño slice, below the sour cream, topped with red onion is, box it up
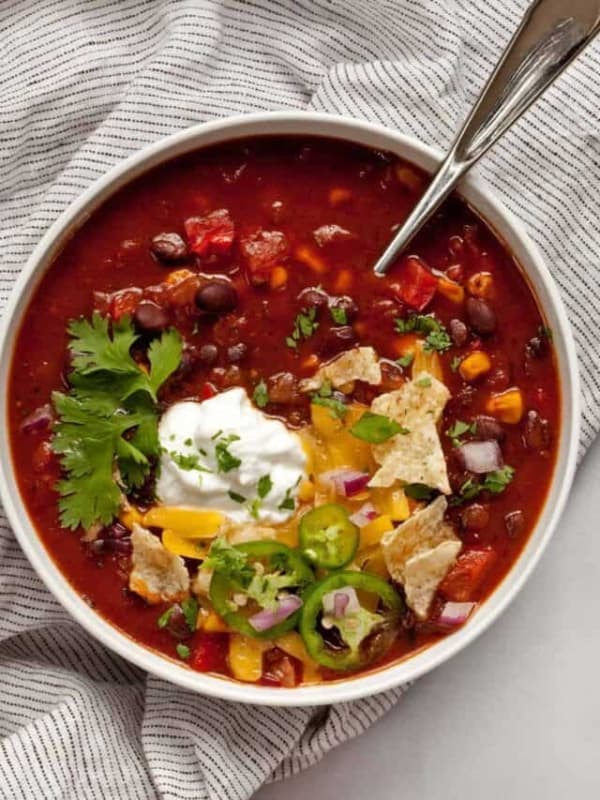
[209,541,314,639]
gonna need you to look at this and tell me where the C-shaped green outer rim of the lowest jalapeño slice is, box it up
[300,571,404,670]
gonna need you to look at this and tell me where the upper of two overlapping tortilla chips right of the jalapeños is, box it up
[381,496,456,583]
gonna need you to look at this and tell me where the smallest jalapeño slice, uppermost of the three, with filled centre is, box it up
[298,503,360,569]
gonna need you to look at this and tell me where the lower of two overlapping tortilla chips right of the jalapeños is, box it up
[404,539,462,620]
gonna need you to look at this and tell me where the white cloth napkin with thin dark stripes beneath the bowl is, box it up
[0,0,600,800]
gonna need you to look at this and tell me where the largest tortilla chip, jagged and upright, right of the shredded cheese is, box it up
[369,372,451,494]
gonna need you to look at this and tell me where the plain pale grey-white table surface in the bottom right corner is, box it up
[255,434,600,800]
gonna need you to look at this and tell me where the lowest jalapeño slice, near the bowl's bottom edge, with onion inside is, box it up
[300,571,404,670]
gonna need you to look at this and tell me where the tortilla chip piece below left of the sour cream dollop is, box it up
[129,524,190,604]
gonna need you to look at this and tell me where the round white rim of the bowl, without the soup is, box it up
[0,112,580,706]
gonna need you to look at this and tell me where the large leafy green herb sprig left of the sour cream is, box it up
[52,312,182,529]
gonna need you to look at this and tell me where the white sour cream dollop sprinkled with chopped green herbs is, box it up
[156,388,306,523]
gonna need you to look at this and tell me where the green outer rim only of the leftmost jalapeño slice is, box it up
[209,541,315,639]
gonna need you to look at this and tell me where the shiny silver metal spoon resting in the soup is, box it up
[373,0,600,276]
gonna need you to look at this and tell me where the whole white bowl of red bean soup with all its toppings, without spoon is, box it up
[2,114,578,704]
